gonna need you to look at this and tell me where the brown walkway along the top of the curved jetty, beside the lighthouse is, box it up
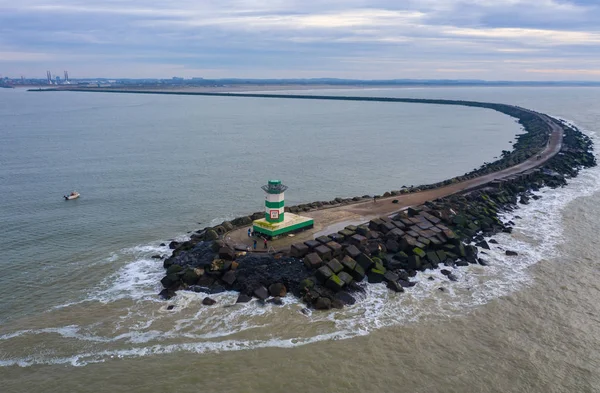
[225,110,563,252]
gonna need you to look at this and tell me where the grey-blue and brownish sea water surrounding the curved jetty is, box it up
[0,87,600,393]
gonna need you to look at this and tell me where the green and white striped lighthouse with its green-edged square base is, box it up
[252,180,314,239]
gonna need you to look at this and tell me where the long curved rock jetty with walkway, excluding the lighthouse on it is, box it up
[149,95,596,309]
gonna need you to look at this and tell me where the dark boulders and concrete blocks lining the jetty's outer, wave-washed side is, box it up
[156,118,596,309]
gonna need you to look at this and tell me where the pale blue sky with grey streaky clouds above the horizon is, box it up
[0,0,600,81]
